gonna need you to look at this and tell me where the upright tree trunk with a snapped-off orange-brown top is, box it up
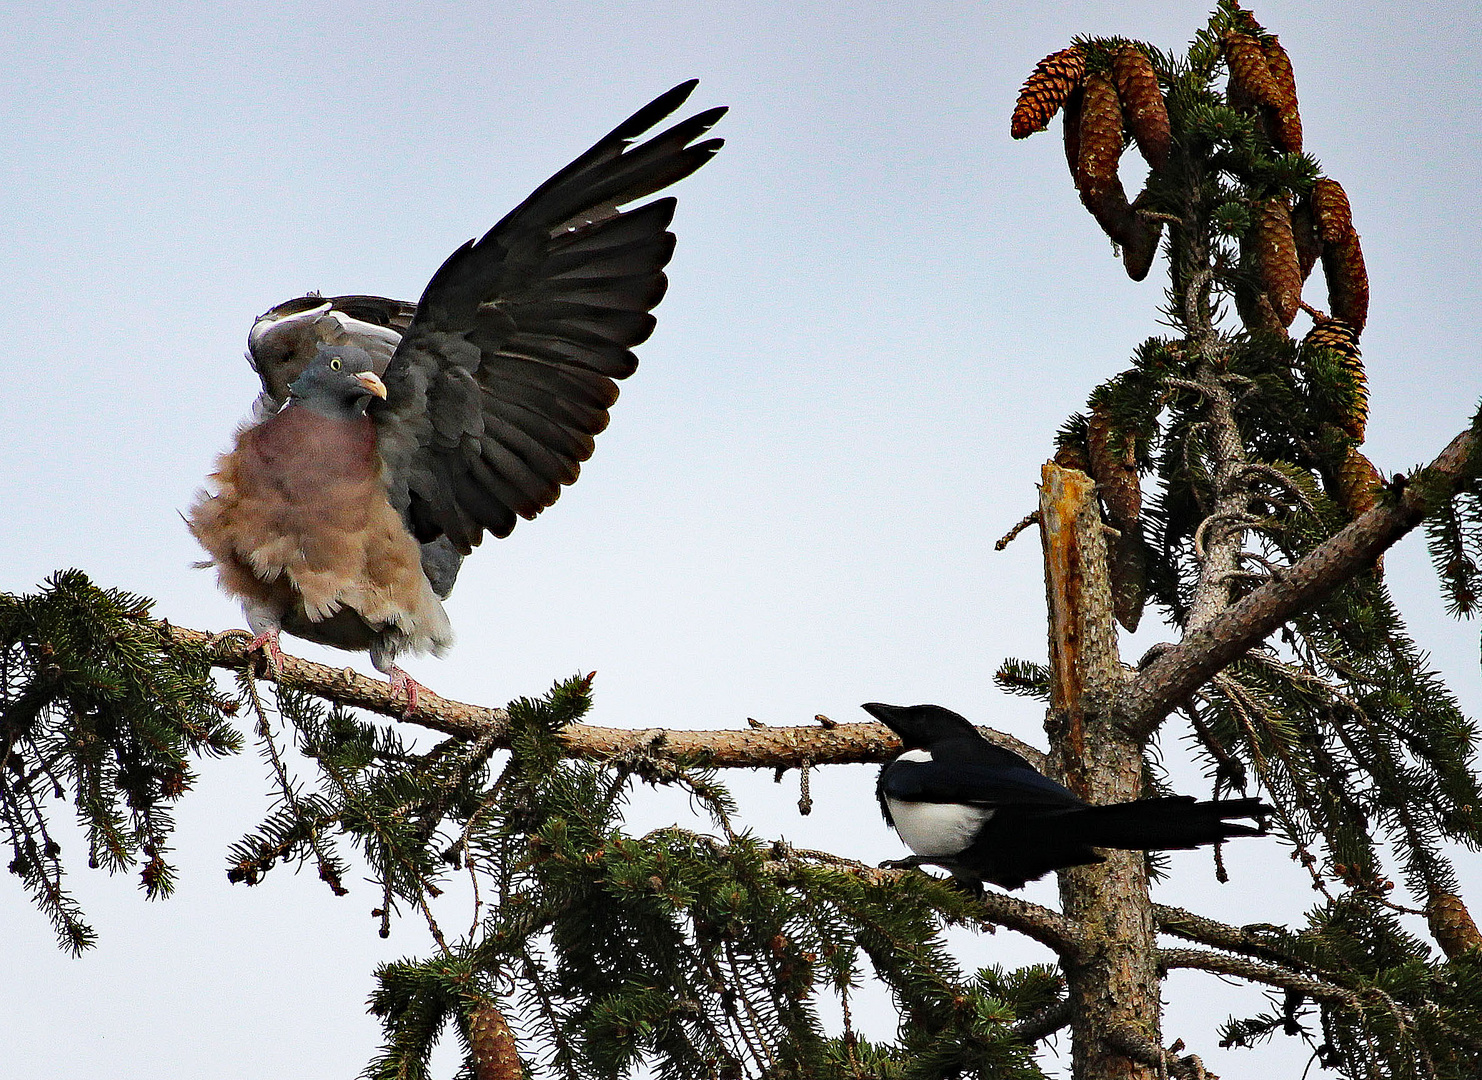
[1040,464,1162,1080]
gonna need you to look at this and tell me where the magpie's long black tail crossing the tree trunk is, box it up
[1067,796,1272,850]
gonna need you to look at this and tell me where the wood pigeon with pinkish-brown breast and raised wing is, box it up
[187,80,726,708]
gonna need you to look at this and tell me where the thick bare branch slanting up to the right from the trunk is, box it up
[1117,431,1478,735]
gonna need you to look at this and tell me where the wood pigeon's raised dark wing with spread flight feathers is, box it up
[375,81,725,554]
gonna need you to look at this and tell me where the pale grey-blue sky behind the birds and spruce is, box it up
[0,0,1482,1080]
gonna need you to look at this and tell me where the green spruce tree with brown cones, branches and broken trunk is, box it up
[0,0,1482,1080]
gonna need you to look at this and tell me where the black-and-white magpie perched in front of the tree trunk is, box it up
[863,702,1272,889]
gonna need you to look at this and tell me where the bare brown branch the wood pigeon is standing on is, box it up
[162,624,1043,769]
